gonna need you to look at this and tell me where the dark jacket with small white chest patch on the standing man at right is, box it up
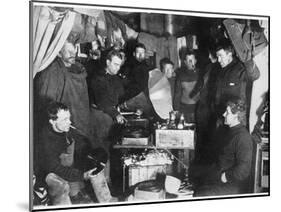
[215,58,247,115]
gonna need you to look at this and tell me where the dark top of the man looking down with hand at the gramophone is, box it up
[91,70,124,118]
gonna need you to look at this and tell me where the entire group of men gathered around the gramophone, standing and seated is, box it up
[34,36,252,203]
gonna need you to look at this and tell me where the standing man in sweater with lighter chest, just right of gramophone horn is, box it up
[174,50,199,122]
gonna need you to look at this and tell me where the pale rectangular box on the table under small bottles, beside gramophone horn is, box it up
[155,129,195,149]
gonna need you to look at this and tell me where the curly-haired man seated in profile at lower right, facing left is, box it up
[189,97,253,196]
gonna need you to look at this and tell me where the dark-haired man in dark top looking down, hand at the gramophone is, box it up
[91,50,126,150]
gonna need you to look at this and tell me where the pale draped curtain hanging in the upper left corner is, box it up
[33,6,75,77]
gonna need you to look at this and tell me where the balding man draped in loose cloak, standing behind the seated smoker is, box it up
[34,41,90,136]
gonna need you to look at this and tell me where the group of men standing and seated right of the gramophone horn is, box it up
[151,39,255,196]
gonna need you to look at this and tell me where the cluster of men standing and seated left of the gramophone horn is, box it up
[34,41,153,203]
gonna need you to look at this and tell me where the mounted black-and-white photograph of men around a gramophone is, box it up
[29,1,271,211]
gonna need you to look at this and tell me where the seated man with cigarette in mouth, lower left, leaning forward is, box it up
[35,102,111,205]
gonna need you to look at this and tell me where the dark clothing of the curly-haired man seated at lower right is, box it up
[190,124,253,196]
